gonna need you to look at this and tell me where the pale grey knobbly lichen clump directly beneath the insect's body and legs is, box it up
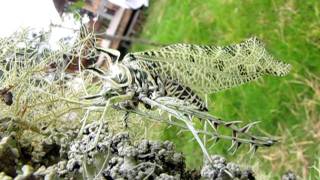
[66,123,188,179]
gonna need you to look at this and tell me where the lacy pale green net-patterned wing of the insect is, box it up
[123,37,290,95]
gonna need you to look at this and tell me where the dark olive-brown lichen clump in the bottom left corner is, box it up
[0,118,76,179]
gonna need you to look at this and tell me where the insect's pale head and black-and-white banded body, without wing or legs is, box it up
[92,50,208,111]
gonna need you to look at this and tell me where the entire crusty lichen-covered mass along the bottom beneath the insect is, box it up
[0,122,296,180]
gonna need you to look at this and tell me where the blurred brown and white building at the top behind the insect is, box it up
[53,0,147,51]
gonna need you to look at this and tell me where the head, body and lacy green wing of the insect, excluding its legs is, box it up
[89,38,290,111]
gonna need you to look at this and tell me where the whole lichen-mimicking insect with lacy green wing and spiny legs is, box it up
[74,25,291,159]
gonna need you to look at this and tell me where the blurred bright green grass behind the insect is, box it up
[132,0,320,179]
